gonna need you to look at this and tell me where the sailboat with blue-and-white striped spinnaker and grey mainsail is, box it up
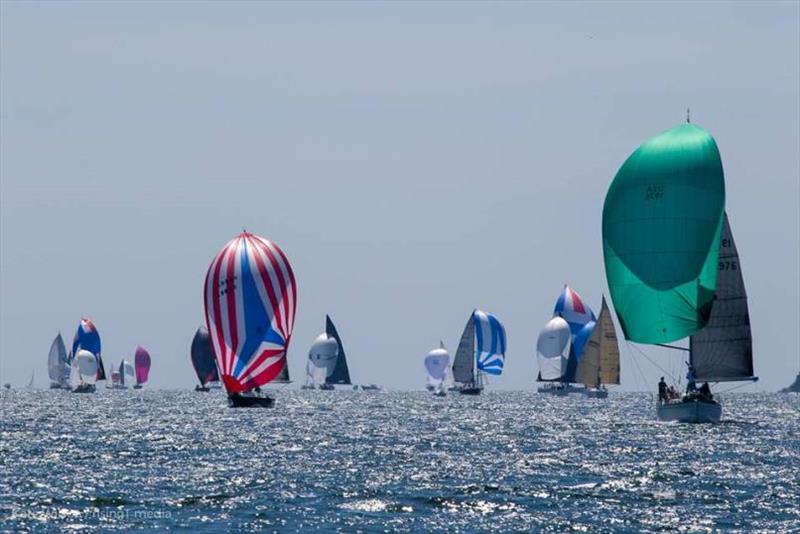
[453,309,506,395]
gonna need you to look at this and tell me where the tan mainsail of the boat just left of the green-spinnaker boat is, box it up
[575,298,620,387]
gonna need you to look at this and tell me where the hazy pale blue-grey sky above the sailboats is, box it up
[0,0,800,391]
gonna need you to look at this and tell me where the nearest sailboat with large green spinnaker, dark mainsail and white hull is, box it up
[603,120,756,423]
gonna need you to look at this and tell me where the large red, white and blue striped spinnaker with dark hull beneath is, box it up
[205,232,297,393]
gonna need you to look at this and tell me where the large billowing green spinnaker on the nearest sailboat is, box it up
[603,124,725,343]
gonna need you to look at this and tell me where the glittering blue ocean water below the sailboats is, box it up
[0,390,800,532]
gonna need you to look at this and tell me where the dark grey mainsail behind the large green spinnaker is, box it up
[689,214,756,382]
